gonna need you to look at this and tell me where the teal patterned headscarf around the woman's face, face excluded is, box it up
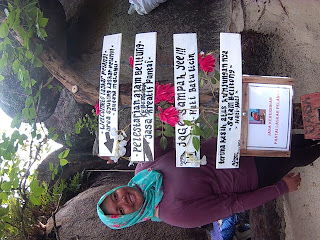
[97,168,163,229]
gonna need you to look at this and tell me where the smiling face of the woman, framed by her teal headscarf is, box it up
[101,187,144,215]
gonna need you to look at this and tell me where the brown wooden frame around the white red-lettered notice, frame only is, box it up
[240,75,294,157]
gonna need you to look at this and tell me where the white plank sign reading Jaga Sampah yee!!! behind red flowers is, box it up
[173,33,200,167]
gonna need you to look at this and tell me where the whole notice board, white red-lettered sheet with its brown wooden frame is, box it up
[240,75,294,157]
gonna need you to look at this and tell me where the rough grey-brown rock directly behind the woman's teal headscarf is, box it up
[48,173,211,240]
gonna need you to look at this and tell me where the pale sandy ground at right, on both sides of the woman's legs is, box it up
[230,0,320,240]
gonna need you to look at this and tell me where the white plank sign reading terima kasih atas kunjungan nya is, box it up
[216,33,242,169]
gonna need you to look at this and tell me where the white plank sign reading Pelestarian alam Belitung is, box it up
[131,32,157,162]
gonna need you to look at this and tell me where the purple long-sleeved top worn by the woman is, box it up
[136,139,288,228]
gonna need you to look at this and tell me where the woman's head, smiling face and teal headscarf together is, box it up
[97,168,163,229]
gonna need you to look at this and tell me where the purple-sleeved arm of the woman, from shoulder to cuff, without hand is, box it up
[159,180,288,228]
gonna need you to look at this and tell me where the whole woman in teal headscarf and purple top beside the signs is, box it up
[97,136,320,229]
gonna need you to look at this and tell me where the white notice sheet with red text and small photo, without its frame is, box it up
[247,83,293,151]
